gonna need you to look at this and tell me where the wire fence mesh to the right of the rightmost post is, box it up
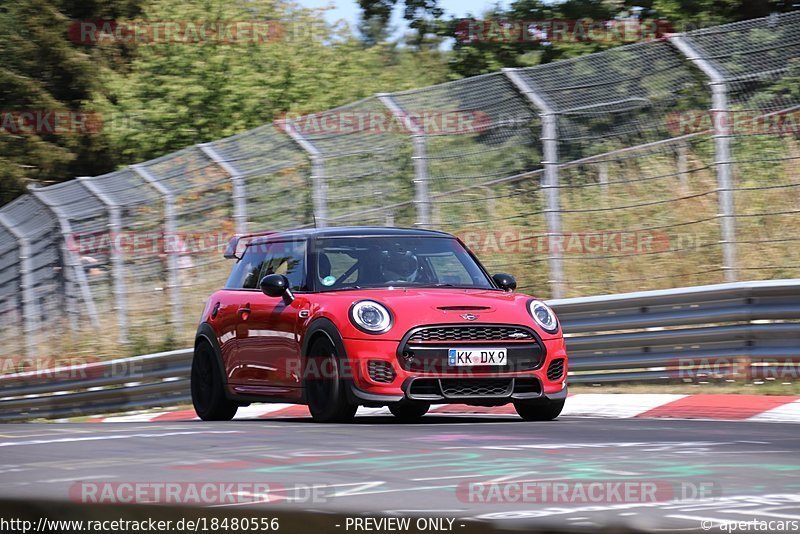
[688,12,800,279]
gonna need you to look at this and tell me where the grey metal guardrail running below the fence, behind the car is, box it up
[0,279,800,421]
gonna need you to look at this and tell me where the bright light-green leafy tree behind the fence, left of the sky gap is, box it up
[97,0,447,162]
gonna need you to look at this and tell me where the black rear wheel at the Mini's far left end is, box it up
[191,341,239,421]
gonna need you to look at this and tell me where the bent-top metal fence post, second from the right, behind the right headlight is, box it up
[503,69,564,299]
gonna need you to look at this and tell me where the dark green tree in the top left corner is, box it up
[0,0,142,203]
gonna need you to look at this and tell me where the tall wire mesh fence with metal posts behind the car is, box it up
[0,12,800,357]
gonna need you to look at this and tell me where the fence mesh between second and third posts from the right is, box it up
[392,73,547,288]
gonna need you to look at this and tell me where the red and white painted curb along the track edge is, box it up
[89,393,800,423]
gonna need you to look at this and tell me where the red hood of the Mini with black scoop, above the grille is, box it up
[310,288,561,340]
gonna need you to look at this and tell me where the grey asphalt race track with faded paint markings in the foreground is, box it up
[0,415,800,531]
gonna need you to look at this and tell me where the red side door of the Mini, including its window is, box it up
[237,241,307,396]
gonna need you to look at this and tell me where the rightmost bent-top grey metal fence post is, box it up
[669,35,737,282]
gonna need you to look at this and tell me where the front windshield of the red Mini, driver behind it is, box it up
[313,236,494,291]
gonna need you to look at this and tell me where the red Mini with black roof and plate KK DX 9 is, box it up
[191,227,567,422]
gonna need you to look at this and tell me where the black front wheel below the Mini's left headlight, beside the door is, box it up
[303,338,358,423]
